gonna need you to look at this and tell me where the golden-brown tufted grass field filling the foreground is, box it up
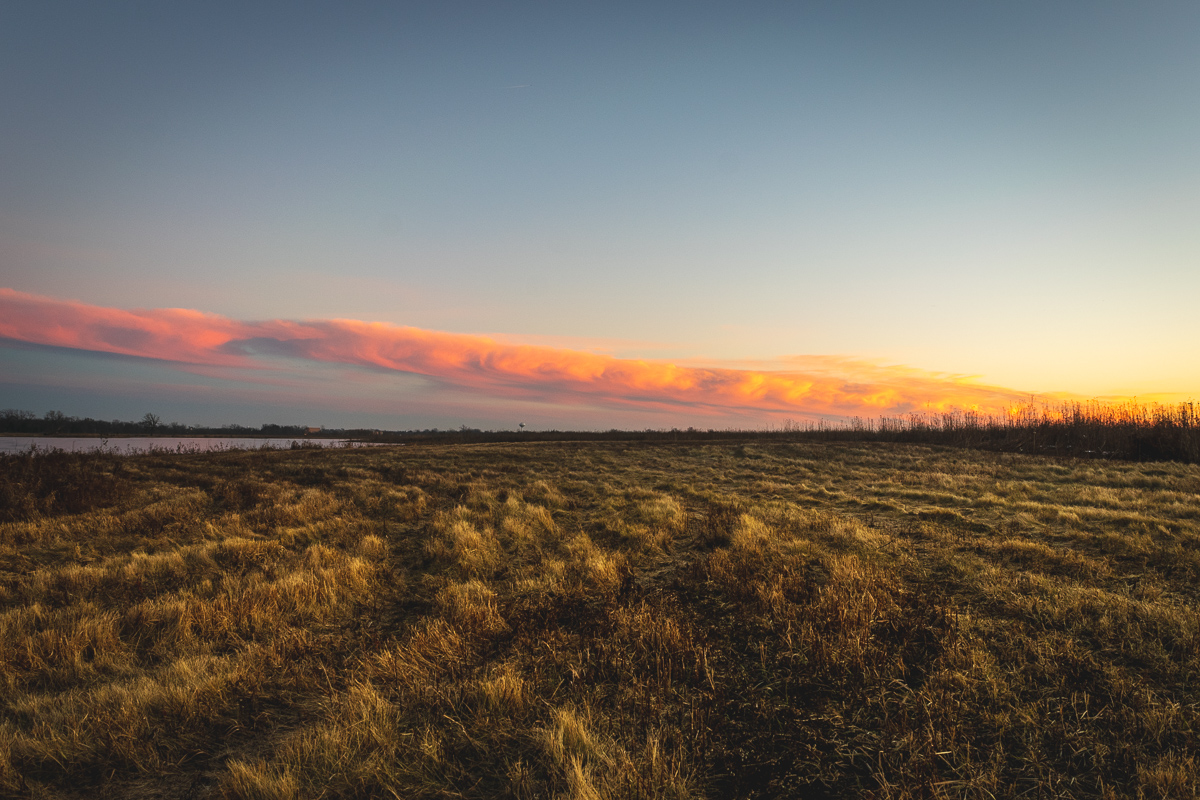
[0,441,1200,799]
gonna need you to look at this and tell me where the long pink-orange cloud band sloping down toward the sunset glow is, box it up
[0,289,1028,417]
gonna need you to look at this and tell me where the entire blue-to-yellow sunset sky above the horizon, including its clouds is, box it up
[0,0,1200,429]
